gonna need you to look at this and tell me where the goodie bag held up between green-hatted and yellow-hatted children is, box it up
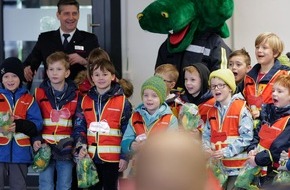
[176,99,201,131]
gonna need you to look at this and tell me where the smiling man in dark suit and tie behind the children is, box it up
[24,0,99,87]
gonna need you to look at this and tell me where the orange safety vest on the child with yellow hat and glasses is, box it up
[208,100,247,168]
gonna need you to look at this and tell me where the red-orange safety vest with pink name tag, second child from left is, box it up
[35,88,78,144]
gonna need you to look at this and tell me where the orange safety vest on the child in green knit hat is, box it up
[131,112,173,136]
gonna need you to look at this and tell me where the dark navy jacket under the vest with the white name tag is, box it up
[72,82,132,163]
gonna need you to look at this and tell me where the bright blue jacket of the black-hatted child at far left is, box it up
[0,88,42,164]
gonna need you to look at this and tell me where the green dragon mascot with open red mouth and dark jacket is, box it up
[137,0,234,87]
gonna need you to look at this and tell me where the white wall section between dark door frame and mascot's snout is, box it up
[122,0,166,105]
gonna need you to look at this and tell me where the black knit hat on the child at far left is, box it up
[0,57,24,83]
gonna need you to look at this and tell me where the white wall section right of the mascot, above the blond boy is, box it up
[232,0,290,65]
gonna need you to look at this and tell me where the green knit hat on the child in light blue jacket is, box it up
[141,76,166,104]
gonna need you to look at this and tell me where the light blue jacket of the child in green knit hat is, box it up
[121,103,178,157]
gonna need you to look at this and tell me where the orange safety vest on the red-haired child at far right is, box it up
[258,117,290,176]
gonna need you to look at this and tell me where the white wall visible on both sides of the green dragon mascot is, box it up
[122,0,290,104]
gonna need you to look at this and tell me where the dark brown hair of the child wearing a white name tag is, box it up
[88,59,116,77]
